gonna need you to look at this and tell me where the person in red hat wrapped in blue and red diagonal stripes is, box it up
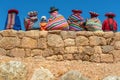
[68,9,84,31]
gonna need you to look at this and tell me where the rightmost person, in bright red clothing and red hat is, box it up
[102,12,117,32]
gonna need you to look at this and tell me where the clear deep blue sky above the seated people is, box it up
[0,0,120,31]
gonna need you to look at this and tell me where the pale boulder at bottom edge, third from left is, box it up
[60,70,88,80]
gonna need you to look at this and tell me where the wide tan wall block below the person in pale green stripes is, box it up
[89,36,106,46]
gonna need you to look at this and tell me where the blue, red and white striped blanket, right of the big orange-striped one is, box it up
[68,14,84,31]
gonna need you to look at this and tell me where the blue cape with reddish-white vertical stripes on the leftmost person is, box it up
[5,13,21,30]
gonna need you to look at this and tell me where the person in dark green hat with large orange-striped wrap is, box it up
[47,7,69,30]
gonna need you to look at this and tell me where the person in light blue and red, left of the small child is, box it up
[24,11,40,31]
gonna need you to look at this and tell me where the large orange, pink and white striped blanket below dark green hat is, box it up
[47,14,69,30]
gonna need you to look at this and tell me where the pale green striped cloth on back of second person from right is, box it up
[86,18,102,31]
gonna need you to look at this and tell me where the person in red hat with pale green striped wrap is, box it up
[86,11,102,31]
